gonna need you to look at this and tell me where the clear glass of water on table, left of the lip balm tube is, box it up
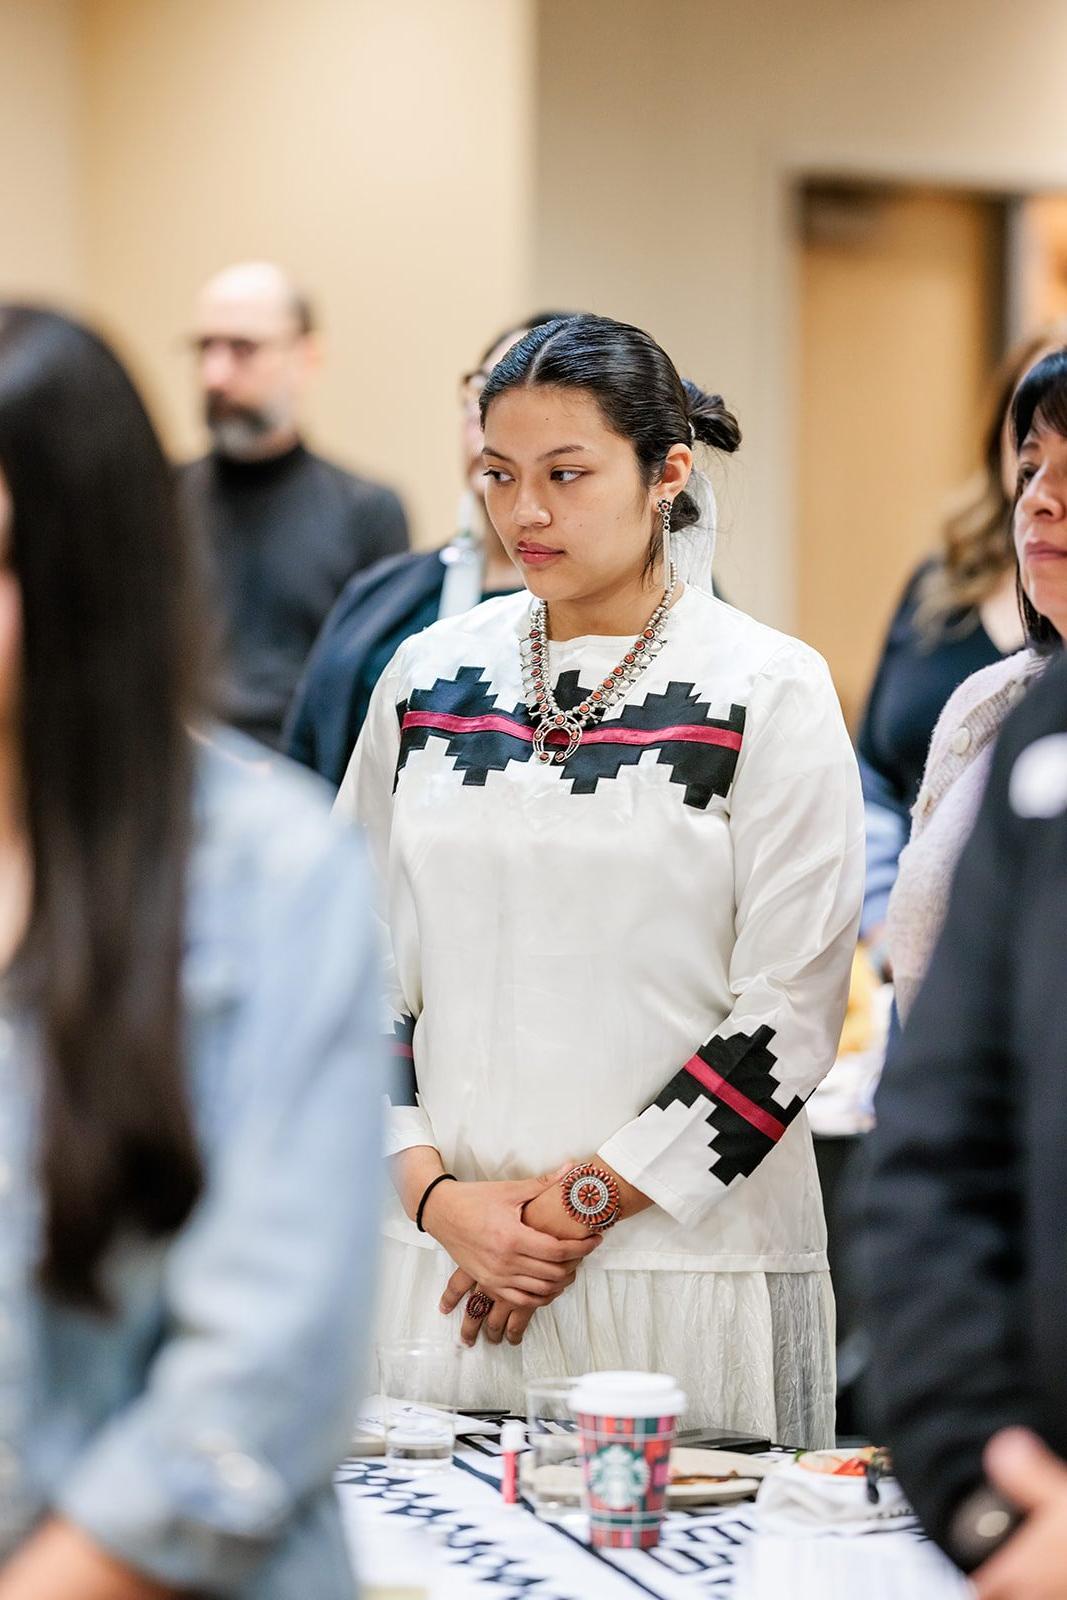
[378,1339,459,1474]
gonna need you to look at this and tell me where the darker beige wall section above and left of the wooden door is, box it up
[534,0,1067,626]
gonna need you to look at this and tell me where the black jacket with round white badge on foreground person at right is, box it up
[856,661,1067,1565]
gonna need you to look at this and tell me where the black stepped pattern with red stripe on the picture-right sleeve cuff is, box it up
[651,1026,805,1184]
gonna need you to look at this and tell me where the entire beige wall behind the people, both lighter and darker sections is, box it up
[8,0,1067,624]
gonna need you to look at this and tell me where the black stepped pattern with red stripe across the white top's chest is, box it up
[394,667,745,810]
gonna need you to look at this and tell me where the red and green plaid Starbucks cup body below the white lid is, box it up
[577,1413,677,1550]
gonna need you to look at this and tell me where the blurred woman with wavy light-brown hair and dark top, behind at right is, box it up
[857,328,1064,976]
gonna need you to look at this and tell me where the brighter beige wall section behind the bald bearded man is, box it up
[83,0,533,544]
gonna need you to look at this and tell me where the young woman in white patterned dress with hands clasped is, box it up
[338,315,864,1446]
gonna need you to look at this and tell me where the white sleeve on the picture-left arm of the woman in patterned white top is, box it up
[334,646,437,1155]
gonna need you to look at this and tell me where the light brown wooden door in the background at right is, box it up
[797,182,1008,730]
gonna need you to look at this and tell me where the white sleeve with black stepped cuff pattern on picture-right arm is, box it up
[600,642,864,1224]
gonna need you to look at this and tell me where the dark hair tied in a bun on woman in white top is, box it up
[482,312,741,530]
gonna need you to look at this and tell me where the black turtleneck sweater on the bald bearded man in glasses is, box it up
[179,445,408,747]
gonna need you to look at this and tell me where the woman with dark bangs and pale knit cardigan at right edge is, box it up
[886,350,1067,1018]
